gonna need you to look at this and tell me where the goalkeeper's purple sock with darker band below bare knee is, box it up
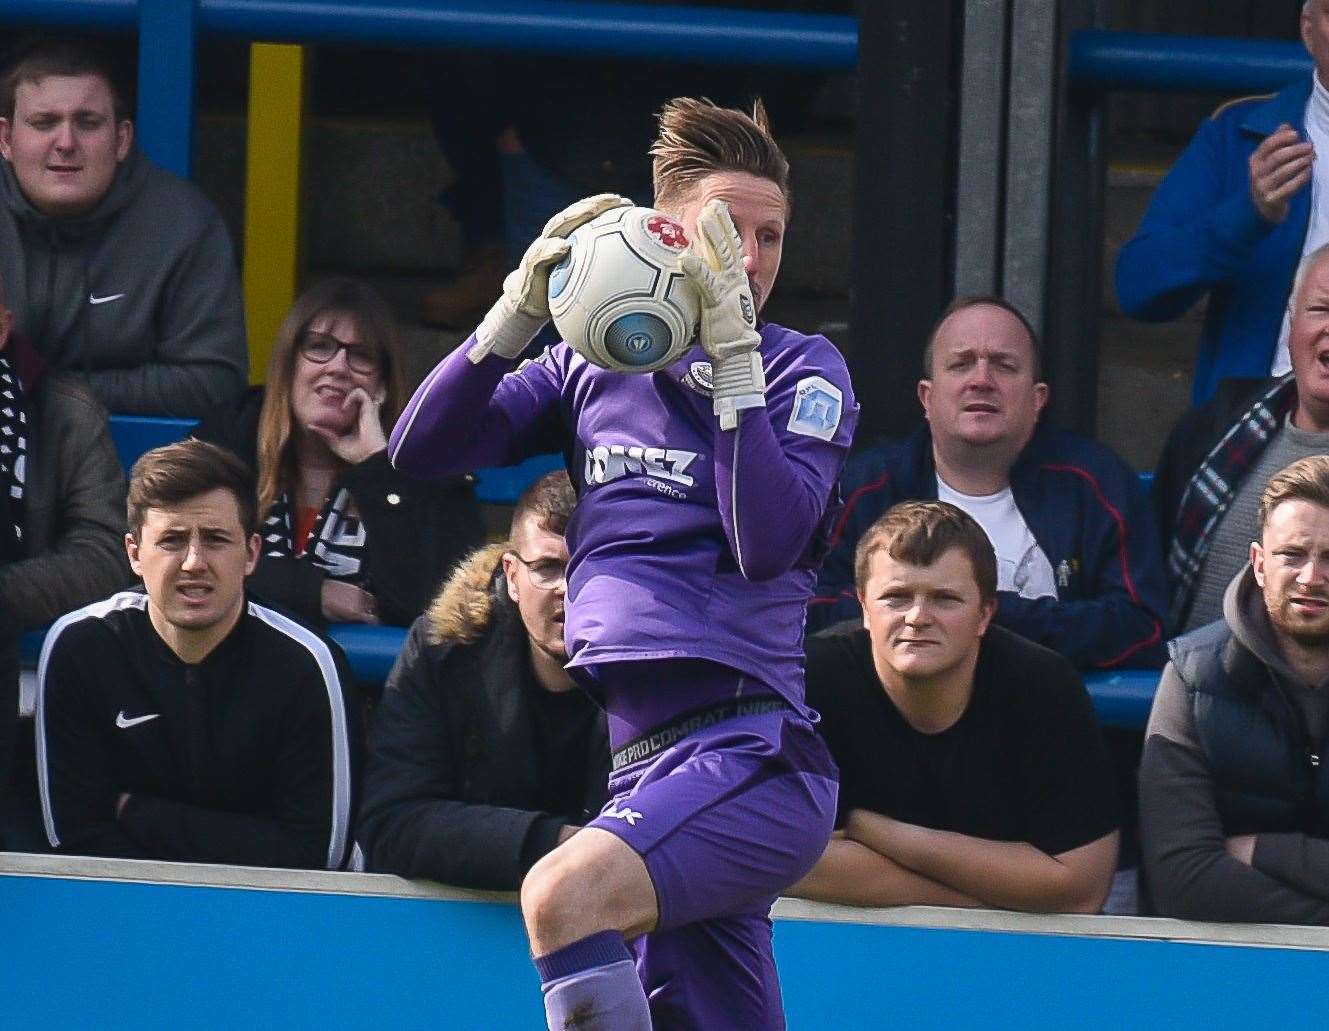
[536,931,651,1031]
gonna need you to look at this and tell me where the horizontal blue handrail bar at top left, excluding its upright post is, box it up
[0,0,859,68]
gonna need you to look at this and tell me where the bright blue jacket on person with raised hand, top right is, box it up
[1116,74,1312,405]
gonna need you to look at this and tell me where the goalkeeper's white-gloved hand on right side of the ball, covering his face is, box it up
[682,201,766,429]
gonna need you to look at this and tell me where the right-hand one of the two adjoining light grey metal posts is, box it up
[1002,0,1057,333]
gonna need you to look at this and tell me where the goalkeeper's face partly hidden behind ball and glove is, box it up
[670,171,789,311]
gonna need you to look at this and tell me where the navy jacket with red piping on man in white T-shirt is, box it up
[808,424,1168,668]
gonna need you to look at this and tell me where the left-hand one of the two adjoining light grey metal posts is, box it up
[956,0,1007,294]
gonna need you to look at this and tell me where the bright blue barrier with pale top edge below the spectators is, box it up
[0,854,1329,1031]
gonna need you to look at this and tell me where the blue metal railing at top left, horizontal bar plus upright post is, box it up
[0,0,859,188]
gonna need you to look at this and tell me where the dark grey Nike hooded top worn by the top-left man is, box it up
[0,149,249,417]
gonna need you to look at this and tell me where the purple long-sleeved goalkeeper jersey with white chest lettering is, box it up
[389,323,859,712]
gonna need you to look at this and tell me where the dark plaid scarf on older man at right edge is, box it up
[1167,375,1297,627]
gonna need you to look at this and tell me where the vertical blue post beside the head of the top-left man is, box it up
[136,0,198,178]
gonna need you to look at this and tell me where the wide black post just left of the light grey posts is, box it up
[848,0,961,444]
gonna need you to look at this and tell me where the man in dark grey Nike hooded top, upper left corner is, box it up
[0,40,249,416]
